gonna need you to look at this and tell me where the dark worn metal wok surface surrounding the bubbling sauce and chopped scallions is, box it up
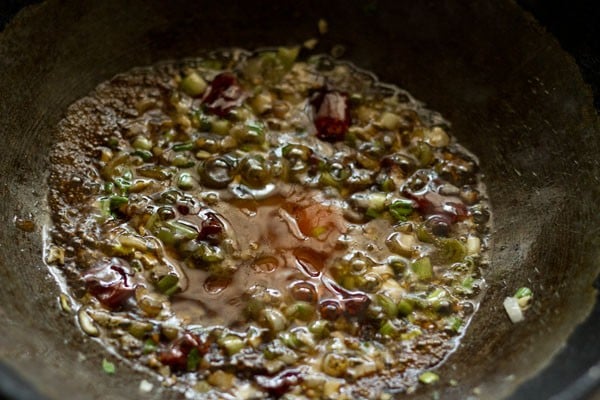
[0,0,600,399]
